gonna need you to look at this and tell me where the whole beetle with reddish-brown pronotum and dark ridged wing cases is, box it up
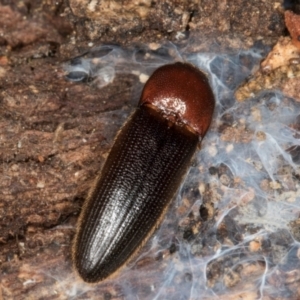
[73,63,215,282]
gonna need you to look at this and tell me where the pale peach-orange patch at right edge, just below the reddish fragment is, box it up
[261,37,300,73]
